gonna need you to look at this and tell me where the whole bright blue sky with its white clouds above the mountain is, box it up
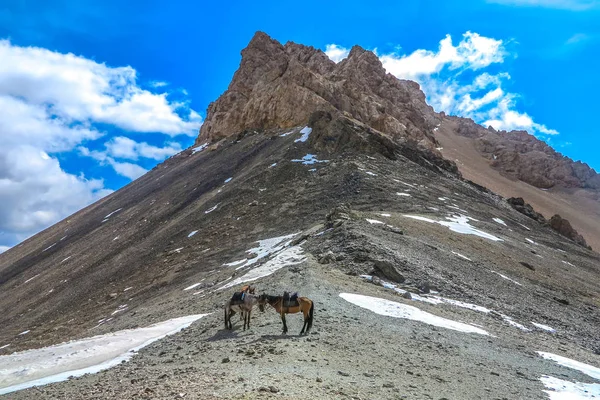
[0,0,600,252]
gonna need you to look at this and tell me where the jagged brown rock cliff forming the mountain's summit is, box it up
[197,32,439,149]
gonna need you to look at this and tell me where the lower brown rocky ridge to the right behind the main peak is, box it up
[447,117,600,190]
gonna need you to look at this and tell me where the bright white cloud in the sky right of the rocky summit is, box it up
[328,32,558,135]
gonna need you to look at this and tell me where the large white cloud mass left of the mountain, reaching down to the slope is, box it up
[0,40,202,251]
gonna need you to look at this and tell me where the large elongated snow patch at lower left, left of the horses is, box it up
[0,314,208,395]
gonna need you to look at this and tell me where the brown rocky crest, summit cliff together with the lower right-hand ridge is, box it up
[196,32,600,191]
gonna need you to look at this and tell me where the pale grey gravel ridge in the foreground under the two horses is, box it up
[7,257,597,399]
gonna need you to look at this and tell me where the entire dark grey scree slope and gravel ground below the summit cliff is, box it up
[0,115,600,399]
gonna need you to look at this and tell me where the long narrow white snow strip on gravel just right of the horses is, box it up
[340,293,489,335]
